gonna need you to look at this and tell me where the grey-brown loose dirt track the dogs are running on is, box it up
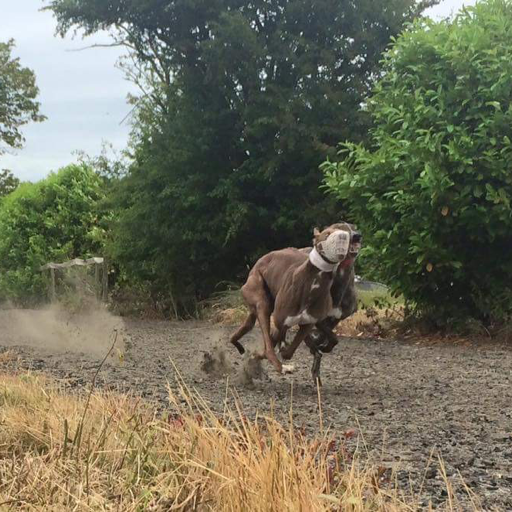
[0,312,512,510]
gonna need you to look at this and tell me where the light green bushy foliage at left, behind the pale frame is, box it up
[0,165,104,302]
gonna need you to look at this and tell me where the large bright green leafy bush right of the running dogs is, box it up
[324,0,512,324]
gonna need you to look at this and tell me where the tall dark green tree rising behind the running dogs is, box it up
[51,0,435,312]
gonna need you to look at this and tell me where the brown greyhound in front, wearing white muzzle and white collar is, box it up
[230,223,358,372]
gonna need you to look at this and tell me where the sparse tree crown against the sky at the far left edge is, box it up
[0,40,45,155]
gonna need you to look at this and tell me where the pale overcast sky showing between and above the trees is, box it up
[0,0,474,181]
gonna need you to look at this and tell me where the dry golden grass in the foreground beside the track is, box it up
[0,375,472,512]
